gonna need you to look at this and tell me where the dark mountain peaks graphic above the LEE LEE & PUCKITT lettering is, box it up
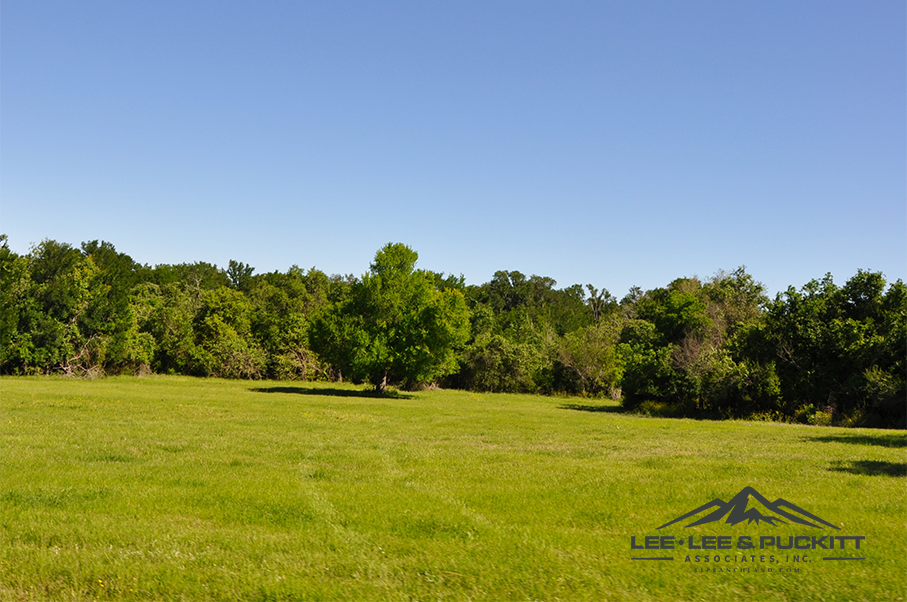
[658,487,838,529]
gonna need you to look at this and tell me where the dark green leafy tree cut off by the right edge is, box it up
[766,270,907,427]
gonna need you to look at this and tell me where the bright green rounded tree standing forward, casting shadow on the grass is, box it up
[313,244,469,392]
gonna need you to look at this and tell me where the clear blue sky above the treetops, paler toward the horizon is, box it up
[0,0,907,297]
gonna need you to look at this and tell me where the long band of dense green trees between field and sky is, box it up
[0,236,907,428]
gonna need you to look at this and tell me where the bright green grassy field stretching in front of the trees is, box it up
[0,376,907,601]
